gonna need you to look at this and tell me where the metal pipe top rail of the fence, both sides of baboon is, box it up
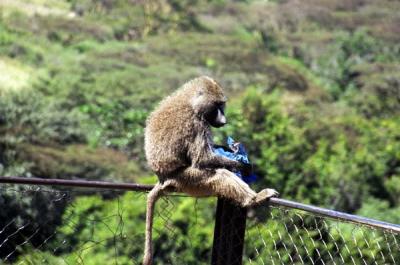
[0,177,400,233]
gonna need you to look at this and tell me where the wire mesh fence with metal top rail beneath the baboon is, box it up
[0,177,400,265]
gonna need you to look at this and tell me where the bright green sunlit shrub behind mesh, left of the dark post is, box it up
[14,192,214,265]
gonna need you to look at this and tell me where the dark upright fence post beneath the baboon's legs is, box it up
[211,198,247,265]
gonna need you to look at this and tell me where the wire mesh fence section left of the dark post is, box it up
[0,184,213,265]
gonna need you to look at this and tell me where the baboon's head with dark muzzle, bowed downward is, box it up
[191,76,226,127]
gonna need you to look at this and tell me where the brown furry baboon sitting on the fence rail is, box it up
[143,76,278,265]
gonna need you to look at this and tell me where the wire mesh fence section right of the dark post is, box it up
[244,203,400,265]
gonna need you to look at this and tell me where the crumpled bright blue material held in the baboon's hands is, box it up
[214,137,257,183]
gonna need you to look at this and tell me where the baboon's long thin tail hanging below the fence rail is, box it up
[143,180,174,265]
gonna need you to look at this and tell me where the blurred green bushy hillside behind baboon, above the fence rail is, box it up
[0,0,400,264]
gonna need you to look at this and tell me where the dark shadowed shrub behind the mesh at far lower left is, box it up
[0,185,66,261]
